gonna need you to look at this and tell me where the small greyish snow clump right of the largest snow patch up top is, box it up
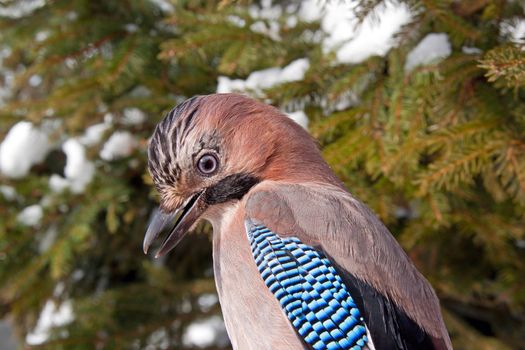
[405,33,452,71]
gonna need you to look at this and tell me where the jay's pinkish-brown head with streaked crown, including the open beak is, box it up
[144,94,339,256]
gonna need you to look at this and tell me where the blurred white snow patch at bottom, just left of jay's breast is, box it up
[182,316,226,347]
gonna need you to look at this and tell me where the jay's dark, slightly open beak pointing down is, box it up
[143,191,207,258]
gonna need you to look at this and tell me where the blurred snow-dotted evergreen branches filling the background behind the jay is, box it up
[0,0,525,350]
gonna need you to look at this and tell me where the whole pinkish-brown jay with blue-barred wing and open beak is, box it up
[143,93,452,350]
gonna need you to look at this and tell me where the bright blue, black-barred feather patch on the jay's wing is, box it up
[246,222,368,350]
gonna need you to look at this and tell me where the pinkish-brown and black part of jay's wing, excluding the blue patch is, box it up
[245,181,452,349]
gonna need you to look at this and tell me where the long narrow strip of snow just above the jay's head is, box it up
[217,58,310,93]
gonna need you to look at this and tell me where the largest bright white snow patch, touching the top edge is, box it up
[299,0,411,63]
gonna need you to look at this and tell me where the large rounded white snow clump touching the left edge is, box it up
[0,121,51,178]
